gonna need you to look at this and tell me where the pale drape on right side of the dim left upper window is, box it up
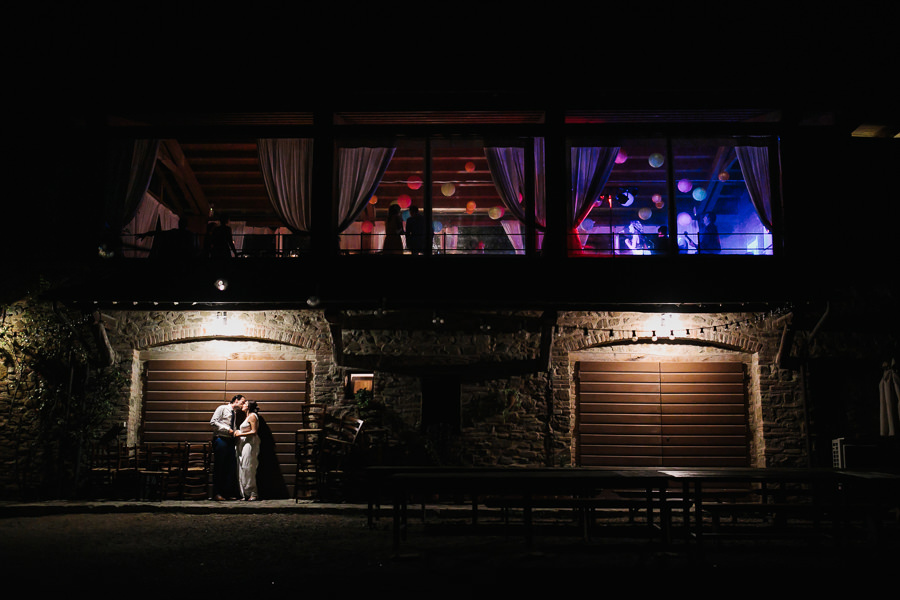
[256,138,313,233]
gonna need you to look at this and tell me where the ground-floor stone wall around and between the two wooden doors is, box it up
[0,302,809,500]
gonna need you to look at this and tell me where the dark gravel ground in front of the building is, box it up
[0,503,898,598]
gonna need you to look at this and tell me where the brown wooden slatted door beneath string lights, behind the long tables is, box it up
[576,361,749,467]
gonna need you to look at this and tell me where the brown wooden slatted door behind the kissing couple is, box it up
[142,360,309,485]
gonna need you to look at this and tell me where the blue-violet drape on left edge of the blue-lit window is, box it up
[568,147,619,250]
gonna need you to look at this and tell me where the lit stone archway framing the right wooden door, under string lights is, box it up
[552,313,807,467]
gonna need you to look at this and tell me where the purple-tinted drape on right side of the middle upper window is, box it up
[484,138,546,253]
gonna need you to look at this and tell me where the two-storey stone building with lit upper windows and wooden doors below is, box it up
[0,9,898,500]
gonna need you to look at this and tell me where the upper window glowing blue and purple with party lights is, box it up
[568,138,775,256]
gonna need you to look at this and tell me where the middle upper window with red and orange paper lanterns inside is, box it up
[336,138,546,255]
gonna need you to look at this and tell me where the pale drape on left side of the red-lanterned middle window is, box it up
[338,147,395,233]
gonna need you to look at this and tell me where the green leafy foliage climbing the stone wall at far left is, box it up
[0,288,121,500]
